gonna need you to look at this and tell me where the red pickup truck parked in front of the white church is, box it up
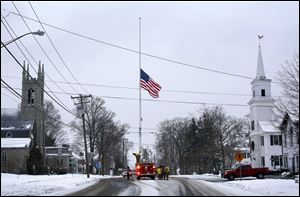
[224,165,270,181]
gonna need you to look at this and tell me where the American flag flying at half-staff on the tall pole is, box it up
[141,69,161,98]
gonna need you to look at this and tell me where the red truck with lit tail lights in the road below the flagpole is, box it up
[135,162,156,180]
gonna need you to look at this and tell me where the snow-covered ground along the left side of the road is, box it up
[1,173,110,196]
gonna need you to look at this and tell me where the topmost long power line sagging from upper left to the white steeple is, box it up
[3,9,280,84]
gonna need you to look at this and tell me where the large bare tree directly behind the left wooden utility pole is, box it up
[71,97,129,174]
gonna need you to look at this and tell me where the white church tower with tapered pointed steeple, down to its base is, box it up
[248,39,282,169]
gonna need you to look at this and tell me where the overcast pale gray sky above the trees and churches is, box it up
[1,1,299,161]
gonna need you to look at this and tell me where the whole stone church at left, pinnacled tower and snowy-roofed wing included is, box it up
[1,62,45,173]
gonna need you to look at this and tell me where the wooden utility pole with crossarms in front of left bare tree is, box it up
[71,94,92,178]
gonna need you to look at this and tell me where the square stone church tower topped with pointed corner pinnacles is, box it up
[21,61,45,152]
